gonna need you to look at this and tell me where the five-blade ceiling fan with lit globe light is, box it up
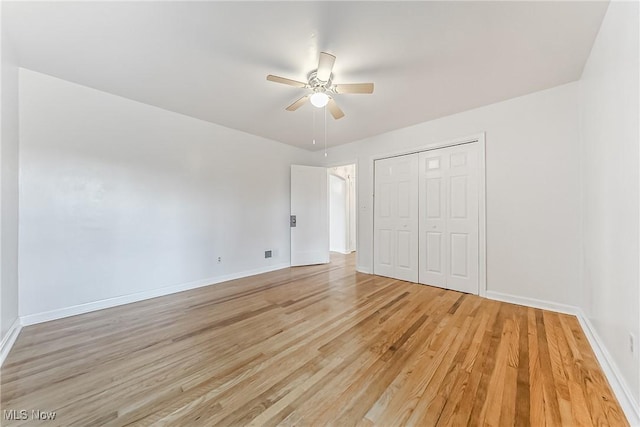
[267,52,373,120]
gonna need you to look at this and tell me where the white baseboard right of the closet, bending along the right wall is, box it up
[487,291,640,427]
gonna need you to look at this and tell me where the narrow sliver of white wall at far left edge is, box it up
[0,7,18,341]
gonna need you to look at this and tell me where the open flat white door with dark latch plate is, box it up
[290,165,329,266]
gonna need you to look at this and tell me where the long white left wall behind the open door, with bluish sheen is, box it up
[19,69,310,316]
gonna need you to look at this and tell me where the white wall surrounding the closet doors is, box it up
[317,83,581,305]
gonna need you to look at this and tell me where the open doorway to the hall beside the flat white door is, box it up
[328,164,356,254]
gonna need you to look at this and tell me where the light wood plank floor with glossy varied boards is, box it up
[1,255,628,426]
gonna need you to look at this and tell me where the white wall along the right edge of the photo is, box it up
[580,1,640,405]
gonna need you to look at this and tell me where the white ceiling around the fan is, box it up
[3,1,608,149]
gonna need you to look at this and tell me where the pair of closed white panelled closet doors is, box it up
[374,142,479,294]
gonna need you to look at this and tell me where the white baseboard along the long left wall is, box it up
[20,263,290,326]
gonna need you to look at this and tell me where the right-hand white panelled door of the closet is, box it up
[419,144,479,294]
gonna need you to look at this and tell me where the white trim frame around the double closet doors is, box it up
[370,132,487,297]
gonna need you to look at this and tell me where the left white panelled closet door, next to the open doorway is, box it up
[373,154,418,282]
